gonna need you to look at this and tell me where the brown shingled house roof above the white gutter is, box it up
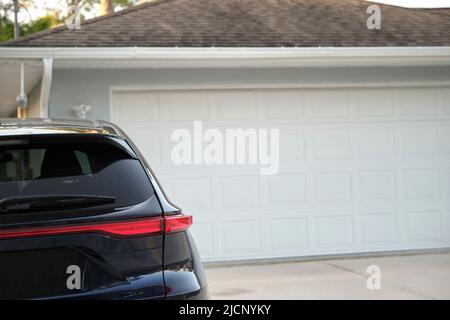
[0,0,450,47]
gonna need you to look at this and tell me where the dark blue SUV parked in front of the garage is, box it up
[0,119,207,299]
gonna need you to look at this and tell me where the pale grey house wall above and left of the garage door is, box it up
[49,67,450,120]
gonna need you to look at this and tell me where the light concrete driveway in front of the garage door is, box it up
[206,253,450,300]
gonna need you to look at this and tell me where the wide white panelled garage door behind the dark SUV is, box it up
[112,87,450,261]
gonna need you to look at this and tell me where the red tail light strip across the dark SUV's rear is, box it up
[0,214,192,239]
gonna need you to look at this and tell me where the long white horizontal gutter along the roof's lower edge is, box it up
[0,47,450,68]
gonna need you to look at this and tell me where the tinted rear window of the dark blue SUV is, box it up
[0,136,154,208]
